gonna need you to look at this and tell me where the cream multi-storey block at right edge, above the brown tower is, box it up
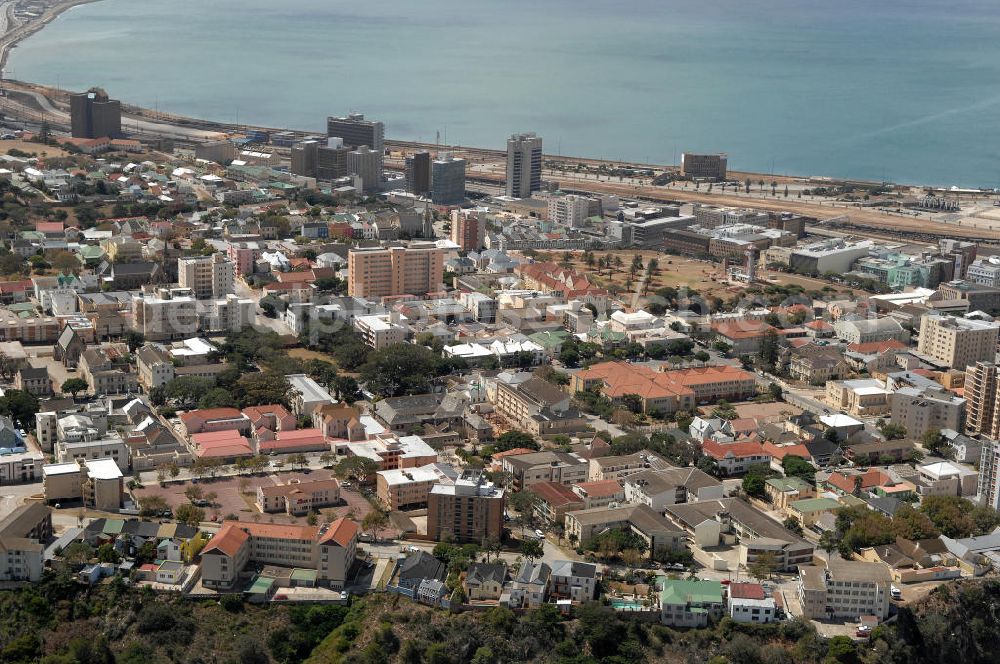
[917,314,1000,369]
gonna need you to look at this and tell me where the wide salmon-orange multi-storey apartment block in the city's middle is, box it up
[347,242,444,297]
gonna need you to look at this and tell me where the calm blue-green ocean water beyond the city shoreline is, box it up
[7,0,1000,187]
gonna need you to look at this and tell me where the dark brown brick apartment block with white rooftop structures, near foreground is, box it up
[427,470,504,544]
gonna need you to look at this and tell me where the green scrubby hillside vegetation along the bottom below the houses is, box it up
[0,575,1000,664]
